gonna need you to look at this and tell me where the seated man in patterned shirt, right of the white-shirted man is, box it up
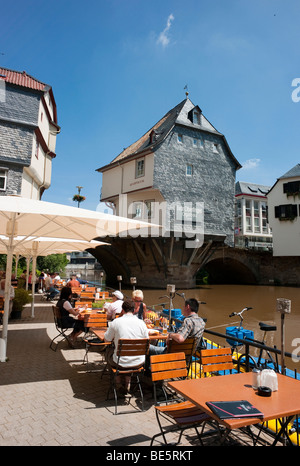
[149,298,205,354]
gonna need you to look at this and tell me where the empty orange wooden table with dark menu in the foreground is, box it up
[168,372,300,445]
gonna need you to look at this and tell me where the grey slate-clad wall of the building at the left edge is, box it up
[0,84,40,195]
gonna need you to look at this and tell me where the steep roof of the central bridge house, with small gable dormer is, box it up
[97,98,241,172]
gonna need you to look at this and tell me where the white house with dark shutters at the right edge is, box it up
[268,164,300,257]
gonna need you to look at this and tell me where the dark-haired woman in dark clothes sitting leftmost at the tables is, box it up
[56,286,85,341]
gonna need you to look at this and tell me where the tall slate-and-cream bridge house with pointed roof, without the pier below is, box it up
[98,97,240,246]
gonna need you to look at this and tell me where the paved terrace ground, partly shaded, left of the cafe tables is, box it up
[0,302,268,447]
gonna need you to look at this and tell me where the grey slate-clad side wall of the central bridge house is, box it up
[154,126,235,246]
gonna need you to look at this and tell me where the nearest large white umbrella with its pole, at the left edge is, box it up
[0,196,157,362]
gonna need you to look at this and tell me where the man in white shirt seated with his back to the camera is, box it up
[104,299,149,393]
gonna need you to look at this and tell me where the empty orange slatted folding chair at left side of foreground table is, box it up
[150,352,211,445]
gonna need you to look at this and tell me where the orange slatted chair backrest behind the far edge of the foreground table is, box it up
[198,347,233,377]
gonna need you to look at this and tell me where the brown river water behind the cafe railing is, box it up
[123,285,300,372]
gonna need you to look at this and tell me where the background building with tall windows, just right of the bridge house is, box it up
[235,181,273,250]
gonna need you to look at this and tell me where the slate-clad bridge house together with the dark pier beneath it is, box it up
[95,95,240,288]
